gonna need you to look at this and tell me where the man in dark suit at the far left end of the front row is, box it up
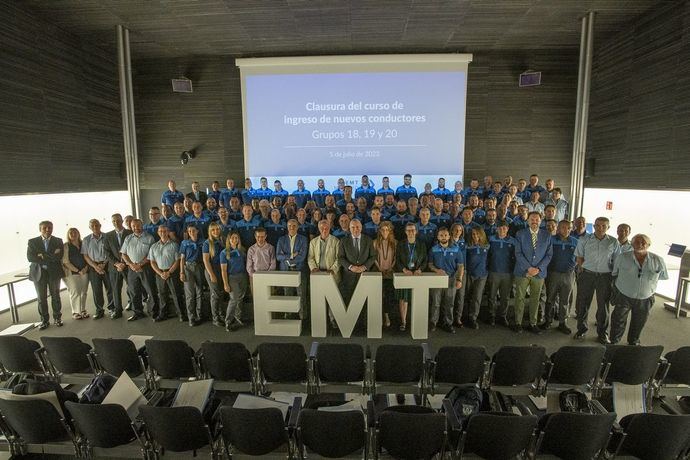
[26,220,64,330]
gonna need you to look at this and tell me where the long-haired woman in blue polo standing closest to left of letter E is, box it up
[220,232,249,331]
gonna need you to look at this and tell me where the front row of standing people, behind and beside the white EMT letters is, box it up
[27,209,668,344]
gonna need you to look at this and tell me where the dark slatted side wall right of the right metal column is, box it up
[585,1,690,189]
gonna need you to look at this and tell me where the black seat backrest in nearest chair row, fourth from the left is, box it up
[220,406,288,455]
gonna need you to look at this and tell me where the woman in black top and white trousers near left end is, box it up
[62,228,89,319]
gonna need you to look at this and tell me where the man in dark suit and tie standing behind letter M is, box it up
[338,219,376,304]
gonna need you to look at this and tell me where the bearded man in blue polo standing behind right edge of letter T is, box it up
[428,227,465,334]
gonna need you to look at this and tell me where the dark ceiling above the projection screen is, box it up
[23,0,663,59]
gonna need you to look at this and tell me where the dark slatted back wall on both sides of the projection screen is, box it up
[134,52,577,205]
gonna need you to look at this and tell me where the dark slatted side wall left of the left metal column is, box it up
[0,1,126,195]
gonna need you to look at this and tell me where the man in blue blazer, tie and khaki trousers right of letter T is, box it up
[513,211,553,334]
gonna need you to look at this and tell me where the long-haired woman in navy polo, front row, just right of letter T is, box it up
[465,227,489,329]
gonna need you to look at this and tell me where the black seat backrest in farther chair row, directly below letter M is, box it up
[316,343,365,382]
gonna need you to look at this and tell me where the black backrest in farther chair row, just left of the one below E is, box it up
[201,341,252,382]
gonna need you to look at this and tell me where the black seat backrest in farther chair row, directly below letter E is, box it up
[258,343,307,382]
